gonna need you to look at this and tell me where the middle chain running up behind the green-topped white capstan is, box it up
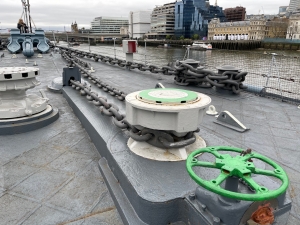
[61,51,126,101]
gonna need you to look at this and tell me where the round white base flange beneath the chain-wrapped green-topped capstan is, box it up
[127,134,206,161]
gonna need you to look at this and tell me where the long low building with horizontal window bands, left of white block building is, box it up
[91,16,128,34]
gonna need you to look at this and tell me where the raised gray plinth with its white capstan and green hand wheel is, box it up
[63,71,291,225]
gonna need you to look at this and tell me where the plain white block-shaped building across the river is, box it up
[129,11,151,38]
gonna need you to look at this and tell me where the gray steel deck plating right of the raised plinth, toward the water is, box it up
[68,47,300,225]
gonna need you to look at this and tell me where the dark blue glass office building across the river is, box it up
[175,0,226,38]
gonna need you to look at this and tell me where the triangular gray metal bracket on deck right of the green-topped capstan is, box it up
[214,111,250,132]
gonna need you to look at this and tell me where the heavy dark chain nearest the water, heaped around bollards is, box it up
[60,47,247,94]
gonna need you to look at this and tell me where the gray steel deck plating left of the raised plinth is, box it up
[0,52,123,225]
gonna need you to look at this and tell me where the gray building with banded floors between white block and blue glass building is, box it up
[147,2,175,39]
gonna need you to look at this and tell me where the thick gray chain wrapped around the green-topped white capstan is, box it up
[70,80,199,148]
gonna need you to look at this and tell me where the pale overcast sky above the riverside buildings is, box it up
[0,0,289,30]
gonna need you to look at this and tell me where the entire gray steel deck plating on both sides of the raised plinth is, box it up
[0,46,300,225]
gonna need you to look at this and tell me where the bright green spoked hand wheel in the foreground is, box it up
[186,146,289,201]
